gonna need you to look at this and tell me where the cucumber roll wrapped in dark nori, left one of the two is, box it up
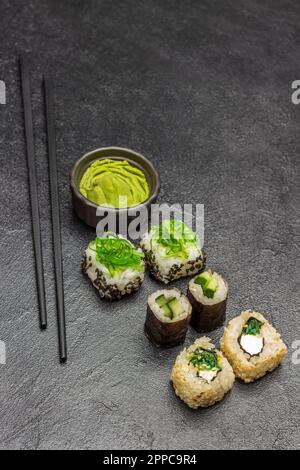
[145,289,192,347]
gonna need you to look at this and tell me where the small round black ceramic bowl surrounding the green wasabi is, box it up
[70,147,160,229]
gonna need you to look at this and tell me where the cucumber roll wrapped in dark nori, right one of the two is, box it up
[187,270,228,332]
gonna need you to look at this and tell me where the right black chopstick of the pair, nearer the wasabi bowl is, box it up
[44,77,67,362]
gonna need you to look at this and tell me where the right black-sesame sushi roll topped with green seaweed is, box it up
[140,219,205,284]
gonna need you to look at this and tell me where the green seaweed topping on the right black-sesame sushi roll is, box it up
[151,219,199,259]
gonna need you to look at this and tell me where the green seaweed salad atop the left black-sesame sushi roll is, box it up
[89,232,144,276]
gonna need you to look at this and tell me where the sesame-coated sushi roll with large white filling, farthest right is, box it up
[221,310,287,383]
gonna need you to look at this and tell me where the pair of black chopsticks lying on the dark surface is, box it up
[20,57,67,362]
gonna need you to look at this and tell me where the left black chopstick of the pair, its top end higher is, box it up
[20,57,47,329]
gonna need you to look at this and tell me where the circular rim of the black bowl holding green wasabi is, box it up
[70,147,160,213]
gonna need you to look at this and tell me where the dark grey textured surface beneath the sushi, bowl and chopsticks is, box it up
[0,0,300,449]
